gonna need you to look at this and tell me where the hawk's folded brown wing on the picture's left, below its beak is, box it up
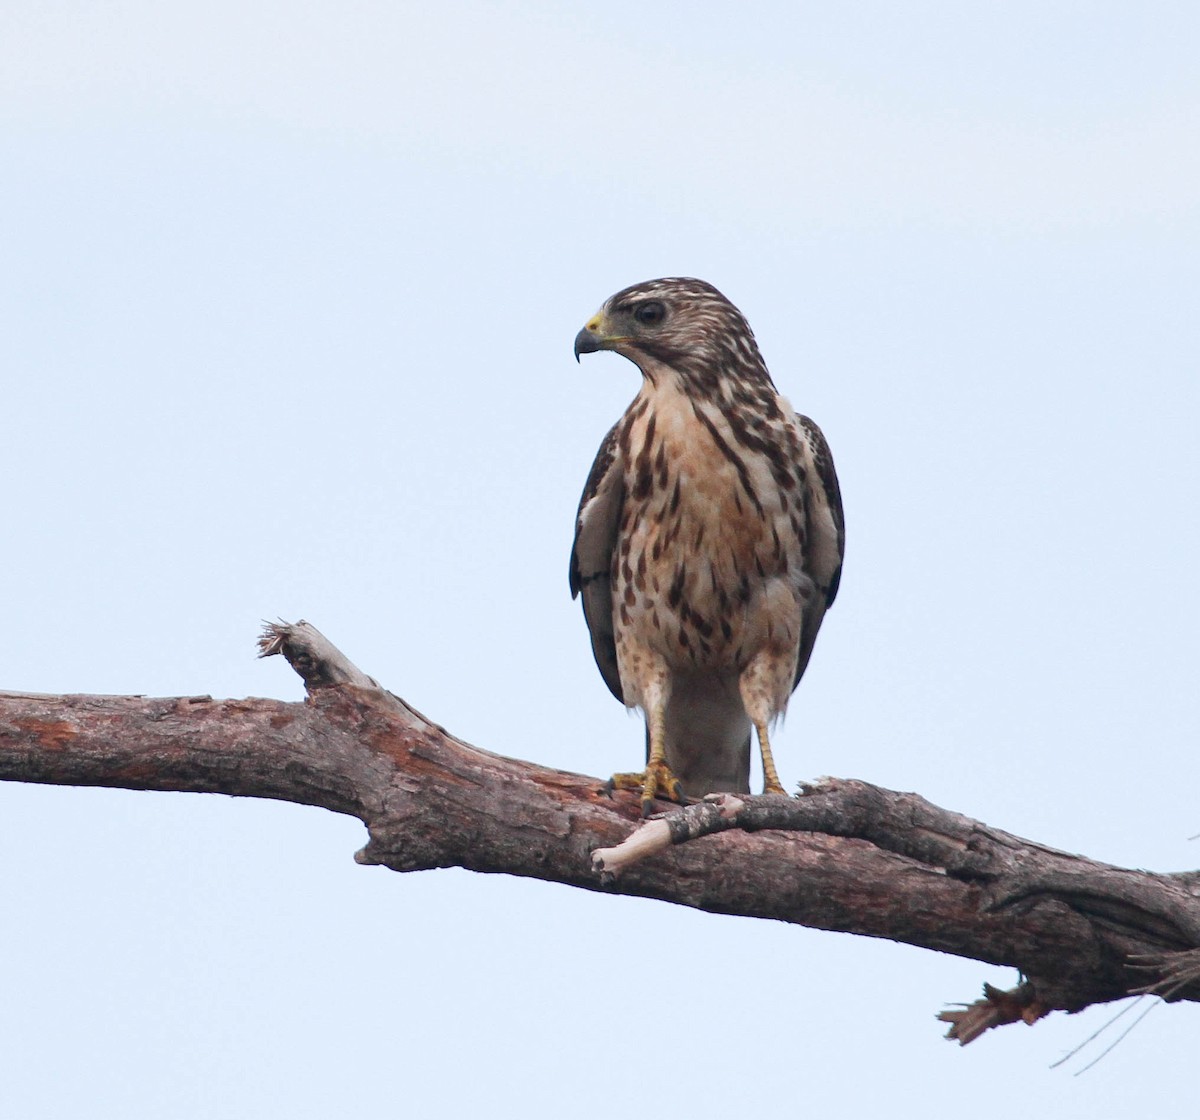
[570,421,625,703]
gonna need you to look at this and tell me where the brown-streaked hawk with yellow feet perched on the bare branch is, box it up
[570,277,845,815]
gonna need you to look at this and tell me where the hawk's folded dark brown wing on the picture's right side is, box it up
[792,414,846,688]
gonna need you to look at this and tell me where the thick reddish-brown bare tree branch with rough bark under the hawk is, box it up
[0,623,1200,1042]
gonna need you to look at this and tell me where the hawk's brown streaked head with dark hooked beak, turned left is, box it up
[575,276,770,385]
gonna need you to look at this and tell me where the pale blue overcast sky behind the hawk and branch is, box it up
[0,0,1200,1120]
